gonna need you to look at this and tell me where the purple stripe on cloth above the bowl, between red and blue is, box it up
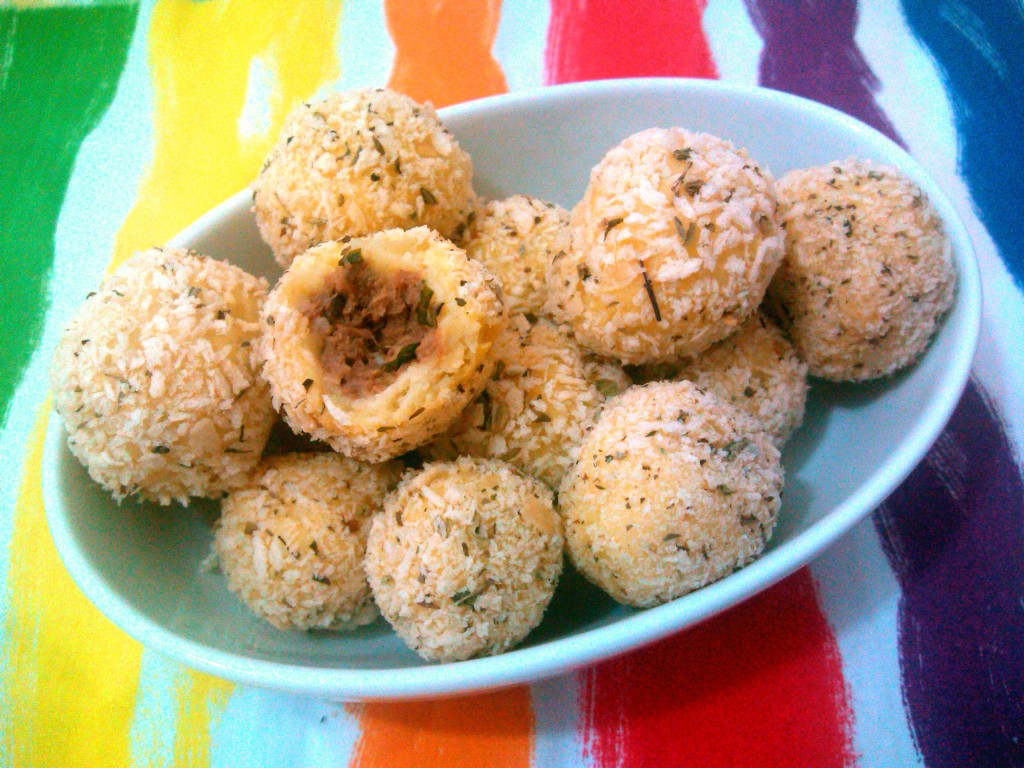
[744,0,902,143]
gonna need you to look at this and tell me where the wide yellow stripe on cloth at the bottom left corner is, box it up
[0,409,142,768]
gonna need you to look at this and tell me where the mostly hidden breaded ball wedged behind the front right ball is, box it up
[641,312,808,450]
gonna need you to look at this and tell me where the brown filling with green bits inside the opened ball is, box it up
[306,261,441,397]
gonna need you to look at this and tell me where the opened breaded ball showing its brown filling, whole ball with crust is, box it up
[260,226,508,462]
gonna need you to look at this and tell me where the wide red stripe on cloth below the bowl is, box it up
[581,568,856,768]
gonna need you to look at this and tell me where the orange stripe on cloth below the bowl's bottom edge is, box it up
[349,686,534,768]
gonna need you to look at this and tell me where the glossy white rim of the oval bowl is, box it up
[43,78,981,700]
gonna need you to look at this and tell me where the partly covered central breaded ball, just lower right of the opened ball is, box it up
[420,316,615,488]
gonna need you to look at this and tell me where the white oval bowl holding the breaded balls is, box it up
[43,79,981,699]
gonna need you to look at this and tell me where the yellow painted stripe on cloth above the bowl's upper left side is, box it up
[111,0,342,268]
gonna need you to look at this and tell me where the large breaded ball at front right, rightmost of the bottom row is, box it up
[558,381,782,607]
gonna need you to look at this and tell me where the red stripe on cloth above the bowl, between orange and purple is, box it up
[545,0,718,84]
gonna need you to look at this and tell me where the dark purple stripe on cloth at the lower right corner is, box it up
[873,382,1024,768]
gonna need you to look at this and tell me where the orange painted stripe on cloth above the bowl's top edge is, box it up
[384,0,508,108]
